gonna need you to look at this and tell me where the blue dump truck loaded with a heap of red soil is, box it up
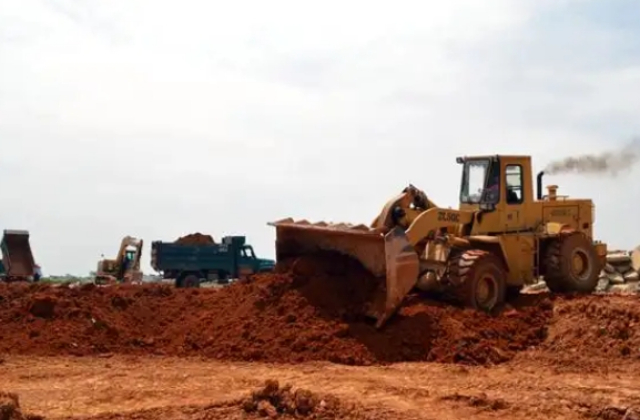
[151,236,275,287]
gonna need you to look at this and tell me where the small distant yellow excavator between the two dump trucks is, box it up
[95,236,143,284]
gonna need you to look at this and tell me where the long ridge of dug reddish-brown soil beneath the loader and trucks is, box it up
[0,253,640,365]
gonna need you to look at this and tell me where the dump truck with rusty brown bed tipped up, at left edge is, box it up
[0,229,40,282]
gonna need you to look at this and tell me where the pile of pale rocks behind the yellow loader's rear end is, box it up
[597,246,640,292]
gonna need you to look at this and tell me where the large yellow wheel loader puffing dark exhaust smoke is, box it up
[269,155,607,327]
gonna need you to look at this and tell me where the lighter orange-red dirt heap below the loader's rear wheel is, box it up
[540,295,640,366]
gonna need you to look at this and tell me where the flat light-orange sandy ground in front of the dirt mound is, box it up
[0,356,640,420]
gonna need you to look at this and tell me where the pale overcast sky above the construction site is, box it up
[0,0,640,274]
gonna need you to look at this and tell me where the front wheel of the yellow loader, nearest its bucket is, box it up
[449,249,507,312]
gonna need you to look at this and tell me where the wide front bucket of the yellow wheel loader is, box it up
[269,219,420,328]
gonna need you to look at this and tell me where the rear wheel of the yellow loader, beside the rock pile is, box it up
[544,232,602,293]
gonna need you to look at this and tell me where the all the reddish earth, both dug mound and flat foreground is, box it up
[5,267,640,420]
